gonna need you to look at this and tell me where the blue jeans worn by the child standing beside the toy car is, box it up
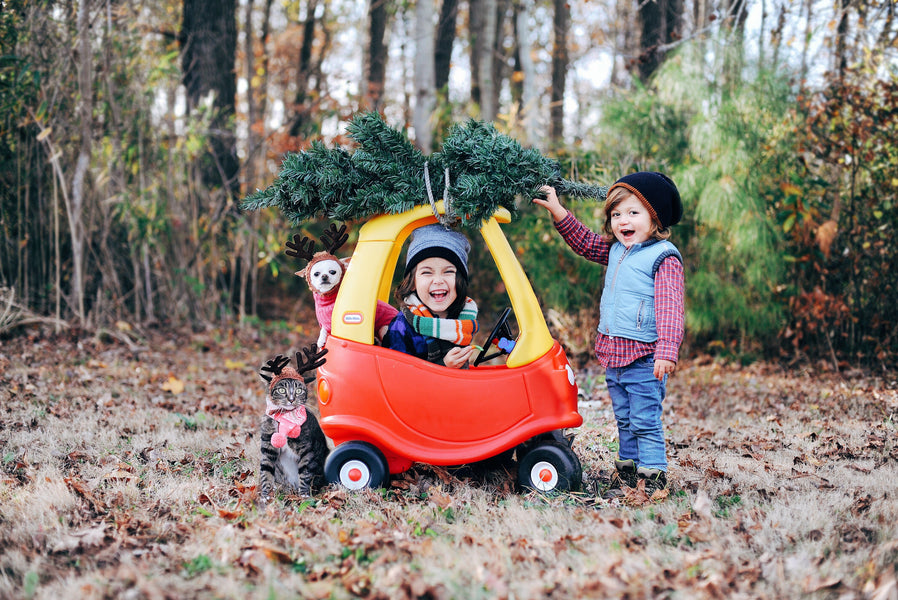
[605,356,667,471]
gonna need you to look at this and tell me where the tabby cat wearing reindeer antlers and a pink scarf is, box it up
[259,344,328,506]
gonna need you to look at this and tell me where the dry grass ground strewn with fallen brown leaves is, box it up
[0,330,898,600]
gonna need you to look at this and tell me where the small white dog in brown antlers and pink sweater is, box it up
[285,223,399,348]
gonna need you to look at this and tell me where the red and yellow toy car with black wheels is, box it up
[317,202,583,491]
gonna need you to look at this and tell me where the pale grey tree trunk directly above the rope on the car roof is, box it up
[413,0,437,154]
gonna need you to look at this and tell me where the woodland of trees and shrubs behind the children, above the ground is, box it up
[0,0,898,370]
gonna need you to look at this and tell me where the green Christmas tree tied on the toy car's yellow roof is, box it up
[242,113,607,227]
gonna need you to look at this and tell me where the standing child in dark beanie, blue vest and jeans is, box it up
[533,172,685,499]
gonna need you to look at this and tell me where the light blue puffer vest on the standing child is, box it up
[598,240,683,343]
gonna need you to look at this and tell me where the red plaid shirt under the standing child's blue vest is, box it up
[555,212,685,368]
